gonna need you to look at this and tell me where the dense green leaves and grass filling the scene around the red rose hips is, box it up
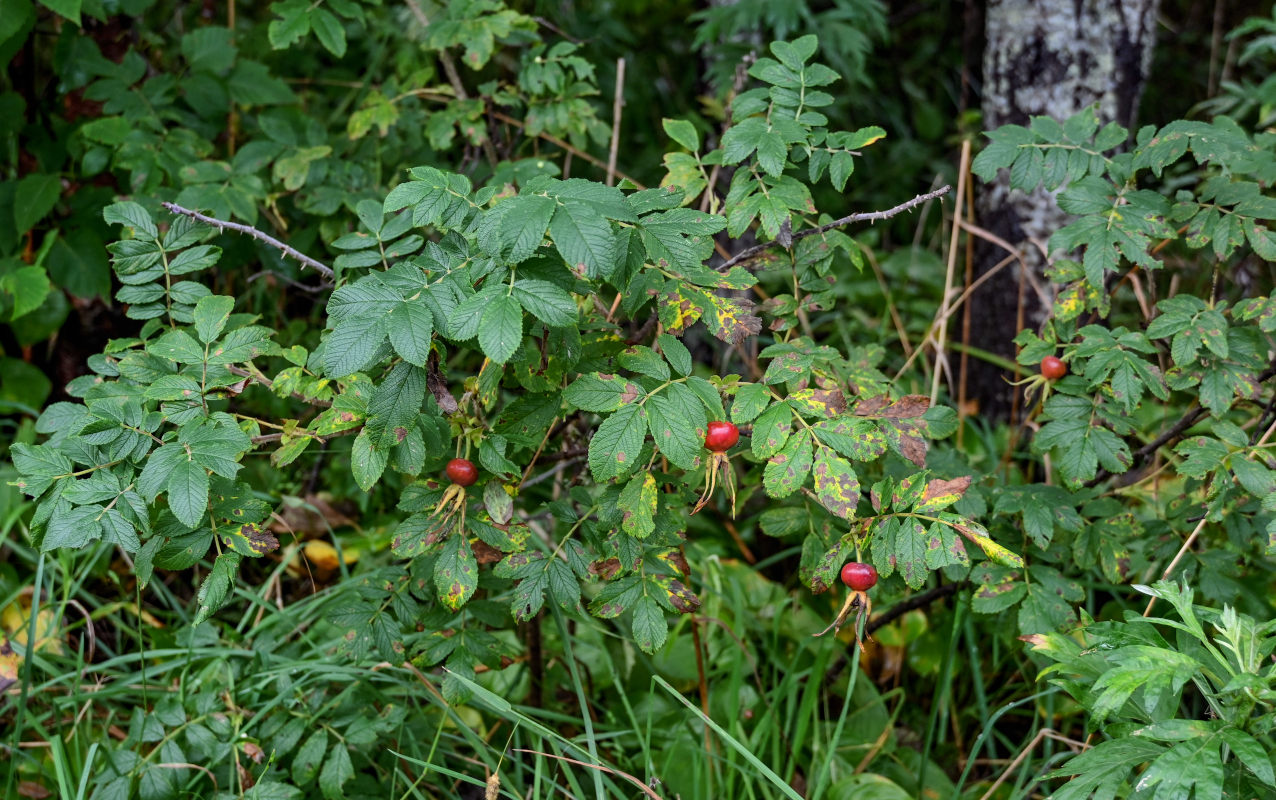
[7,0,1276,800]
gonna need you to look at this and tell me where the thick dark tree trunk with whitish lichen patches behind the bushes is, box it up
[968,0,1160,419]
